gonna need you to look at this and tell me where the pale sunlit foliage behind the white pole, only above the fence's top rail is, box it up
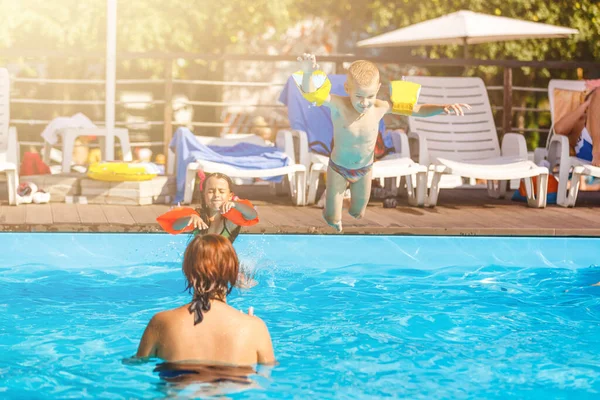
[0,0,291,53]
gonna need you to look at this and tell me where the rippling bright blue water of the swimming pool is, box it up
[0,234,600,399]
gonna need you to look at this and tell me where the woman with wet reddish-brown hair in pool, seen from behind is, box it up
[137,234,275,366]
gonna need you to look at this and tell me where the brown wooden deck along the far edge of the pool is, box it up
[0,187,600,236]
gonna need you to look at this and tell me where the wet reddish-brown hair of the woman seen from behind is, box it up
[182,234,239,325]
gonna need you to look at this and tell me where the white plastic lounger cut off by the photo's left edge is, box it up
[0,68,19,205]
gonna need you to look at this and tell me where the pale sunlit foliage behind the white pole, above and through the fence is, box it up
[0,0,300,137]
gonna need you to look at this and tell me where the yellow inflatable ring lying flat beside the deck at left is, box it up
[87,161,159,182]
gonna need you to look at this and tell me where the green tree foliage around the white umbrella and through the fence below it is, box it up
[302,0,600,148]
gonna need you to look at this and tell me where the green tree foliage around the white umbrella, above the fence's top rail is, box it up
[302,0,600,60]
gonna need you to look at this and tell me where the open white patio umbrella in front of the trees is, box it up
[357,10,579,58]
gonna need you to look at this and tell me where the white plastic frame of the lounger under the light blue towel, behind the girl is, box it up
[168,132,306,206]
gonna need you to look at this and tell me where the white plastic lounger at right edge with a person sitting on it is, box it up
[547,79,600,207]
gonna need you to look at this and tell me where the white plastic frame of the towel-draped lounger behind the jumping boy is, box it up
[282,130,427,206]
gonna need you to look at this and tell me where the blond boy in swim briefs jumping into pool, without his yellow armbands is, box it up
[298,53,471,232]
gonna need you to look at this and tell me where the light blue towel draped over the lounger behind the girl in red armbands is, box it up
[169,127,290,203]
